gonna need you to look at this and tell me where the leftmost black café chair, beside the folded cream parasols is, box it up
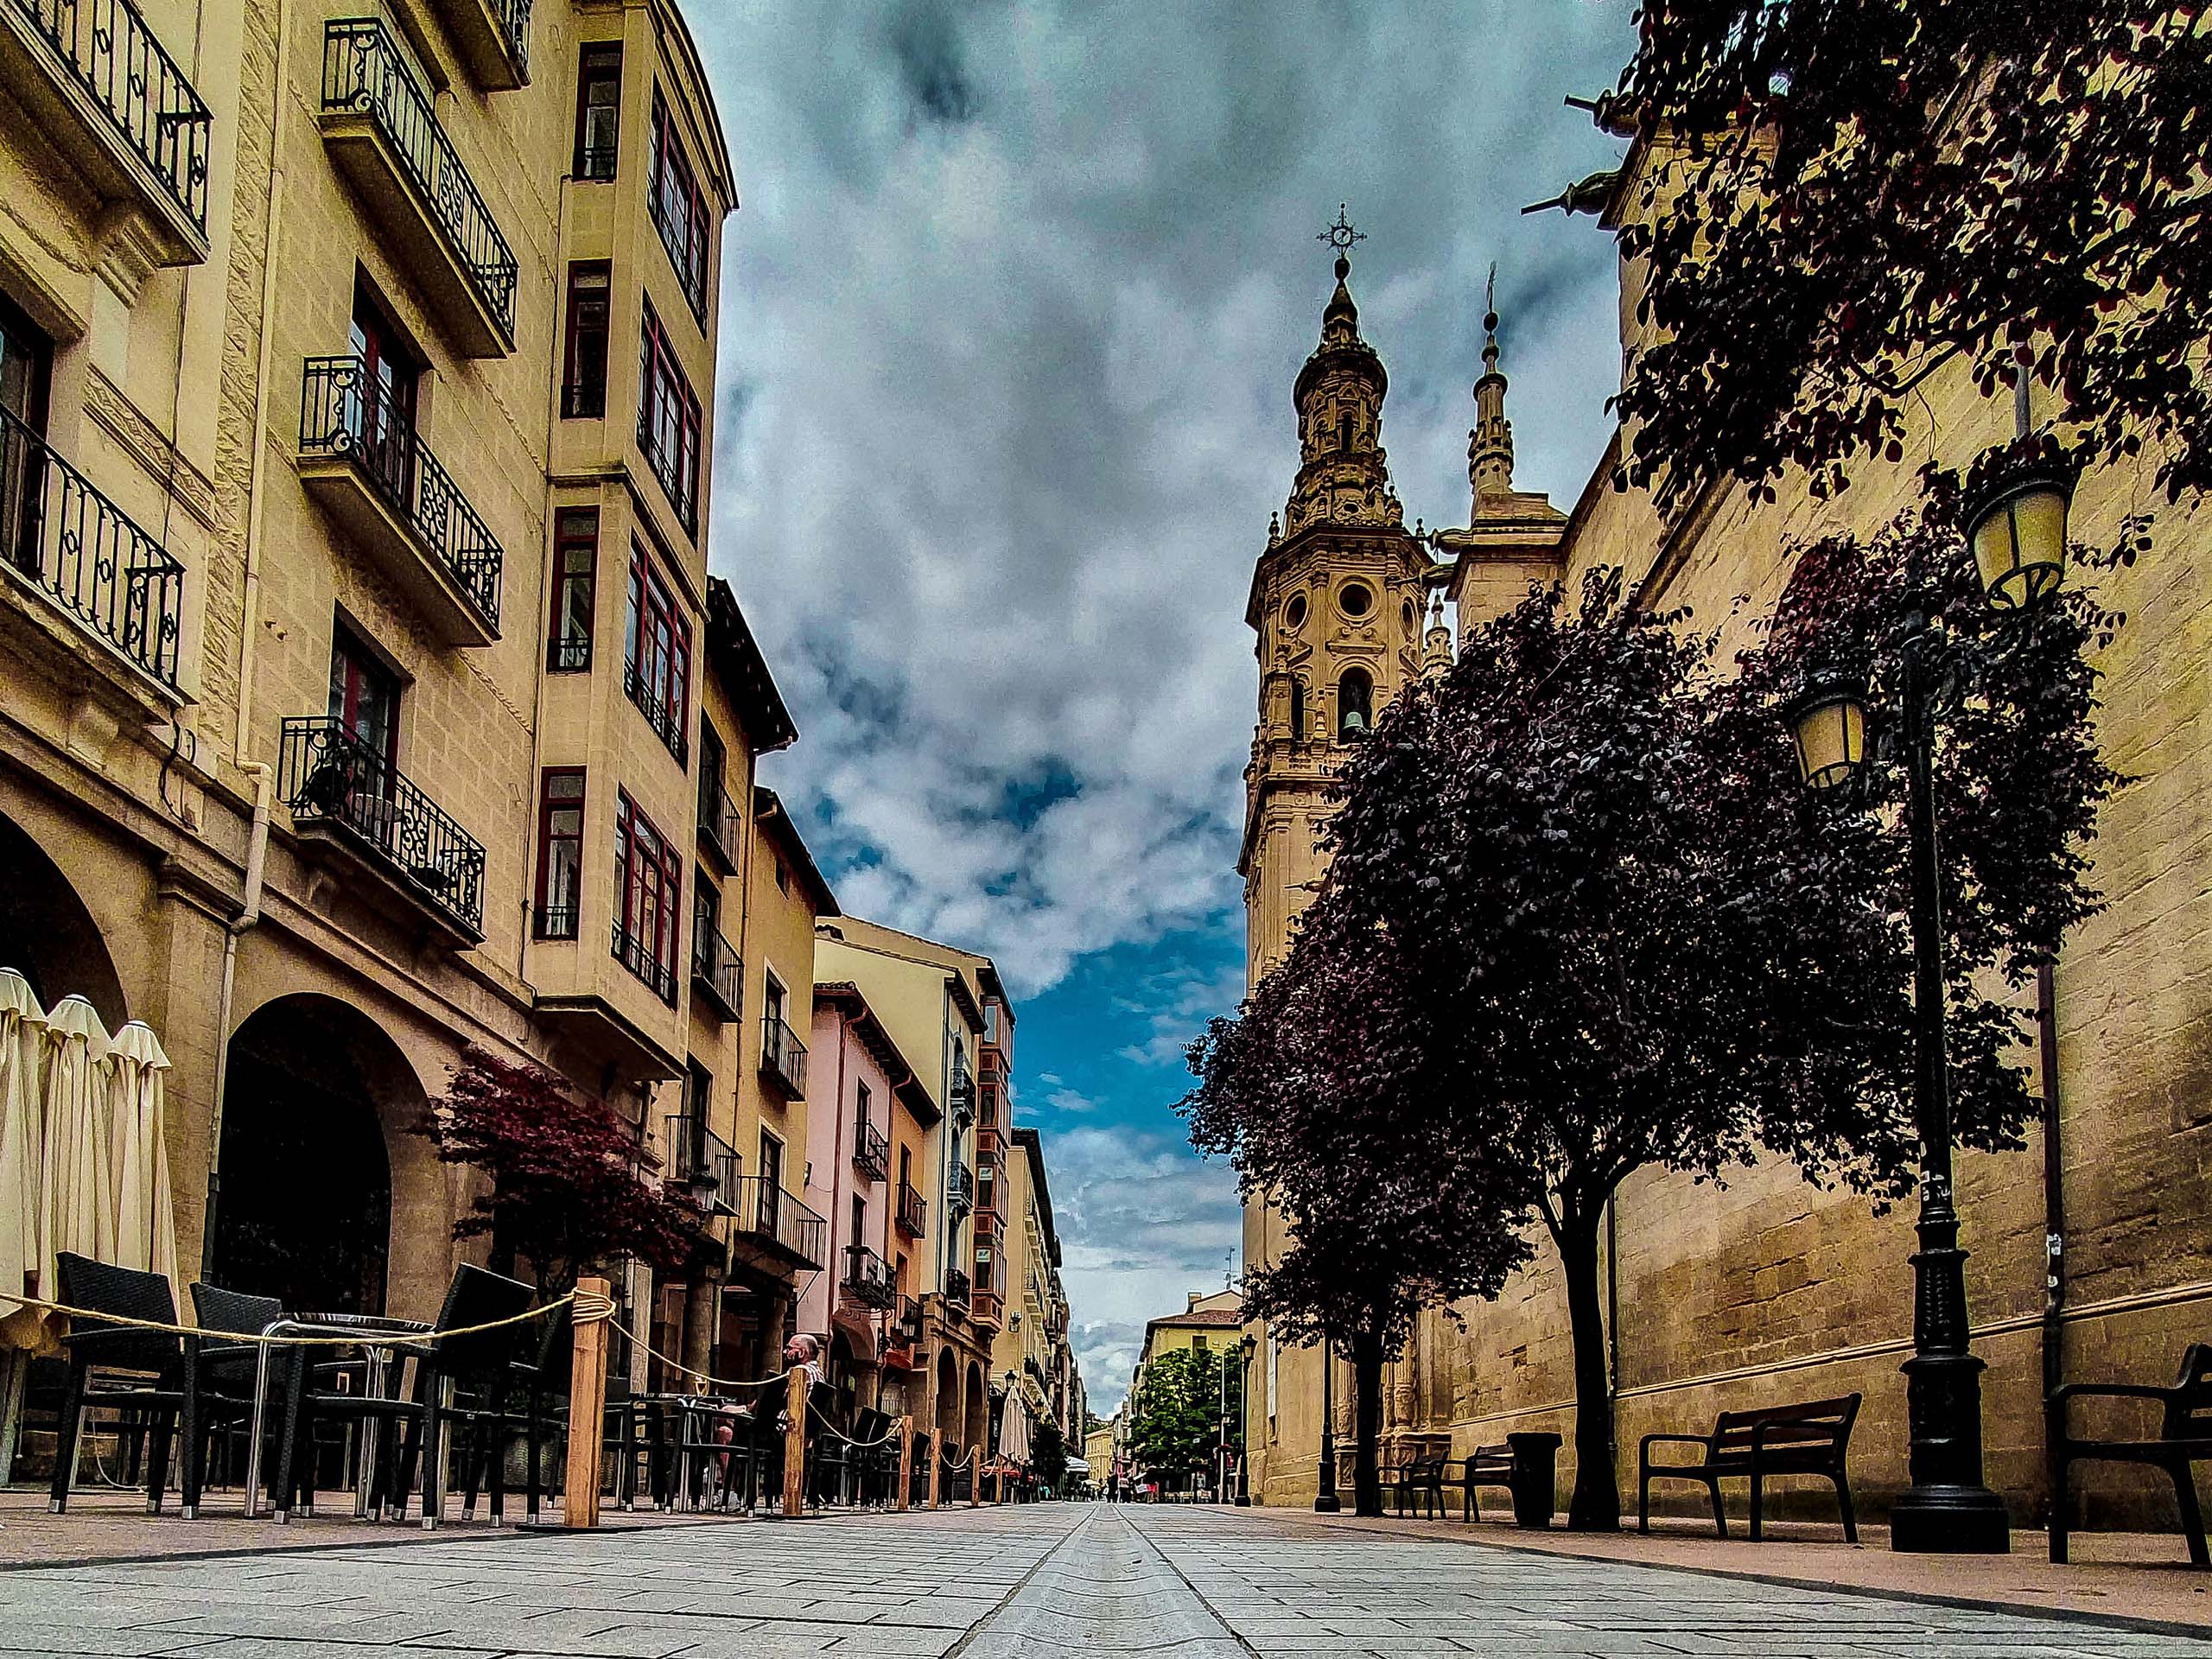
[48,1249,252,1516]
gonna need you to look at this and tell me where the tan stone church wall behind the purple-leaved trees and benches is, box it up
[1245,133,2212,1526]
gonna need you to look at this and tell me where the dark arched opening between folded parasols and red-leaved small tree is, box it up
[208,993,427,1314]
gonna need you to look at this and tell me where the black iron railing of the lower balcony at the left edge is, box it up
[0,410,183,688]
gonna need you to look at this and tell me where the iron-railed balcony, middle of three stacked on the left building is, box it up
[299,356,505,646]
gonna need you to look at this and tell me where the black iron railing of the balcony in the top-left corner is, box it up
[7,0,213,230]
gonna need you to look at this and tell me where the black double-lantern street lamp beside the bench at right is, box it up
[1789,442,2073,1555]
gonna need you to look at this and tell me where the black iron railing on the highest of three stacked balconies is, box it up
[323,17,515,336]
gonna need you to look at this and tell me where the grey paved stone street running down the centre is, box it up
[0,1504,2212,1659]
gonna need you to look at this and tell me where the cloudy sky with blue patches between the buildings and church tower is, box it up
[688,0,1630,1414]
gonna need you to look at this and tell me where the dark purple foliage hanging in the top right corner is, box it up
[1599,0,2212,505]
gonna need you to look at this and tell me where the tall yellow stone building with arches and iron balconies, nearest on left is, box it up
[0,0,834,1451]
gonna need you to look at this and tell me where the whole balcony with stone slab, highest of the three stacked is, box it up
[321,17,515,356]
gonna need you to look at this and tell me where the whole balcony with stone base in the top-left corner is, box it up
[0,0,213,287]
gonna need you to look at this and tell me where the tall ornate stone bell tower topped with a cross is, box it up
[1236,213,1442,1502]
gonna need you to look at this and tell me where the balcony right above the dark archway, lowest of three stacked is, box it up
[276,715,485,944]
